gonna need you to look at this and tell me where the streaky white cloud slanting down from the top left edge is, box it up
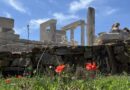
[5,0,27,13]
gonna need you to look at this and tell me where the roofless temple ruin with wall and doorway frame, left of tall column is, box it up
[40,19,85,46]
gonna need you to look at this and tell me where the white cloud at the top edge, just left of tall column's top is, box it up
[69,0,95,12]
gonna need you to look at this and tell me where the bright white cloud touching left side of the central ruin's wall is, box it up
[29,18,49,29]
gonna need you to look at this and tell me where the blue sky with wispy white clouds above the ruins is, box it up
[0,0,130,42]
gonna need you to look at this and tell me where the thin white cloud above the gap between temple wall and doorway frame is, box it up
[53,12,79,24]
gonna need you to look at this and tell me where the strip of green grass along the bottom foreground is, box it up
[0,75,130,90]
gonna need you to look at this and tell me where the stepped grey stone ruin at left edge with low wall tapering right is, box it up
[0,17,44,52]
